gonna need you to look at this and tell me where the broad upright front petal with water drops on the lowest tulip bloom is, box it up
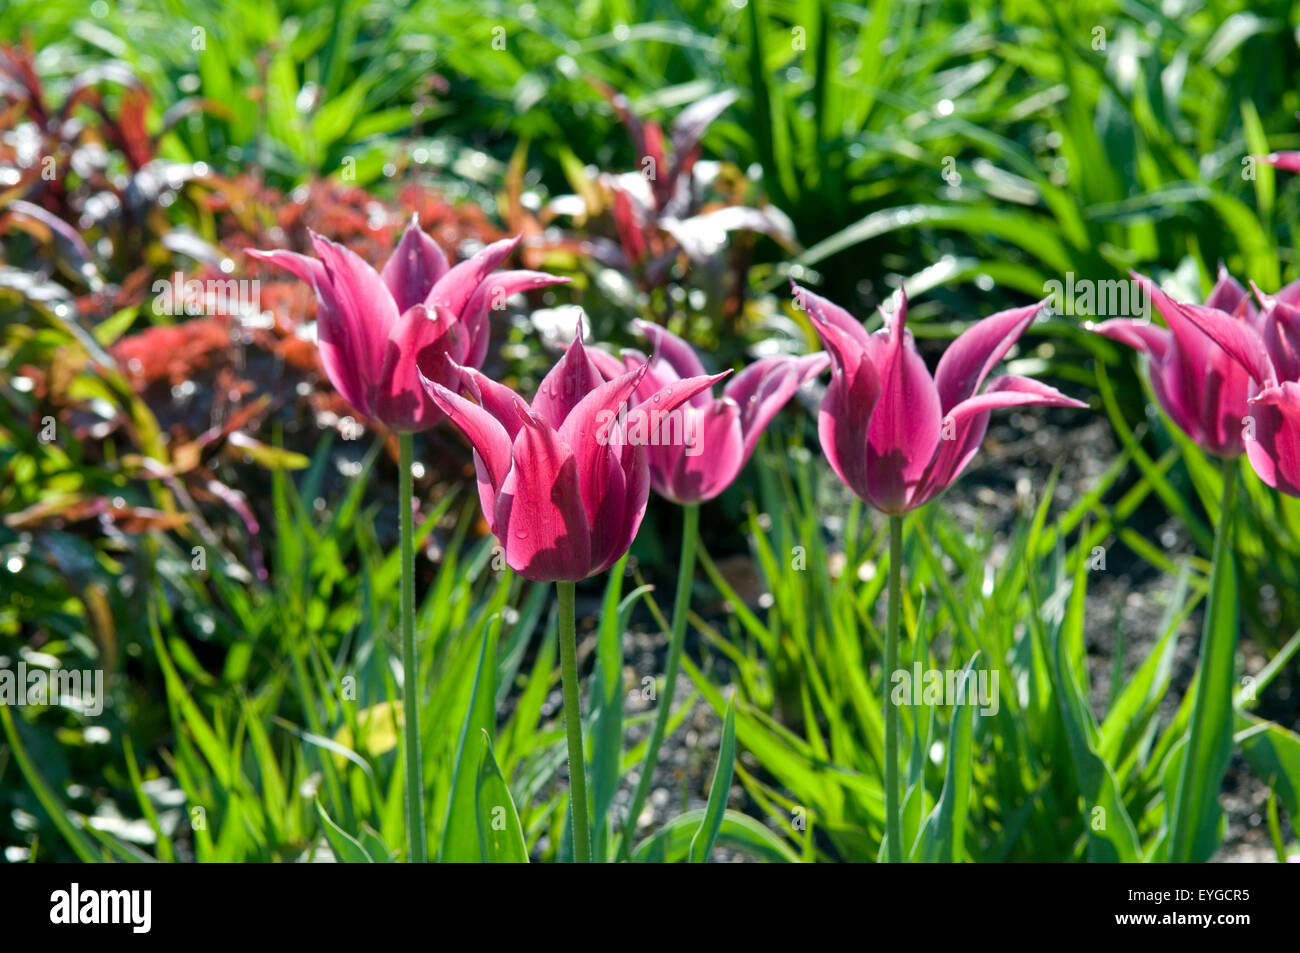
[495,410,592,582]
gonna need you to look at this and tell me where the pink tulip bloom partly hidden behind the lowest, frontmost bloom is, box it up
[589,321,829,503]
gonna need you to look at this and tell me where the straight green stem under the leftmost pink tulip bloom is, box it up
[398,433,429,863]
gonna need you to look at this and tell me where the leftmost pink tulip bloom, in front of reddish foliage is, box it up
[248,218,568,432]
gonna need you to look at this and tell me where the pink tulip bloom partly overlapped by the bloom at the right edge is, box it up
[1089,265,1258,458]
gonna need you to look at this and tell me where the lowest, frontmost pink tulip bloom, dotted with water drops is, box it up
[425,328,725,582]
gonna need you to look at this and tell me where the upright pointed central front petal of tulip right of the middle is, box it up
[867,294,943,514]
